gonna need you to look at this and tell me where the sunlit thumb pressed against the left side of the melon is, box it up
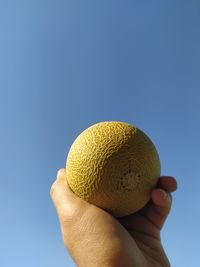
[50,169,89,222]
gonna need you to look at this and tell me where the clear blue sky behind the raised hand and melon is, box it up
[0,0,200,267]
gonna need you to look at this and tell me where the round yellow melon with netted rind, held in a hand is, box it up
[66,121,160,217]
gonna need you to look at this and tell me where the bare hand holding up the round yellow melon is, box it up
[50,169,177,267]
